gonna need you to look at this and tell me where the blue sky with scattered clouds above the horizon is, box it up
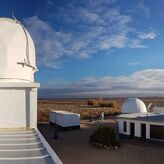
[0,0,164,98]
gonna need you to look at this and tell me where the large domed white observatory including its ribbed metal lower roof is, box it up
[0,18,62,164]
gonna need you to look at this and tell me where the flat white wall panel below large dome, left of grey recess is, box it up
[0,88,26,128]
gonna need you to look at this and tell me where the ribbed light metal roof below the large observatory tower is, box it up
[0,130,59,164]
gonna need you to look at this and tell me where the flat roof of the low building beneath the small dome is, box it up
[118,113,164,123]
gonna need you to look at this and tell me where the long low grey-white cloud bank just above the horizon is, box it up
[39,69,164,98]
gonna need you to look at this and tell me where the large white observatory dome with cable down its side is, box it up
[0,18,37,82]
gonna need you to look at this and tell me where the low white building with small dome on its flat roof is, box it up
[118,98,164,142]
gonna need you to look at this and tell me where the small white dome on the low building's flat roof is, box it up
[121,98,147,113]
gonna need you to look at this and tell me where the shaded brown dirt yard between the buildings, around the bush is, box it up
[39,119,164,164]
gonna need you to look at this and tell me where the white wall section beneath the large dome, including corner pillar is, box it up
[0,84,37,128]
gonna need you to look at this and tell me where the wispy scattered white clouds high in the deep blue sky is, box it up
[24,0,156,68]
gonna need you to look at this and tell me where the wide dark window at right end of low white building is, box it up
[150,125,164,140]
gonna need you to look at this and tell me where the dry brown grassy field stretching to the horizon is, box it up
[38,97,164,123]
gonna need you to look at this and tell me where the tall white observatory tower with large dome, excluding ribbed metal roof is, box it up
[0,18,39,128]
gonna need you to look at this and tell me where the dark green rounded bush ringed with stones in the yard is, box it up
[90,126,120,147]
